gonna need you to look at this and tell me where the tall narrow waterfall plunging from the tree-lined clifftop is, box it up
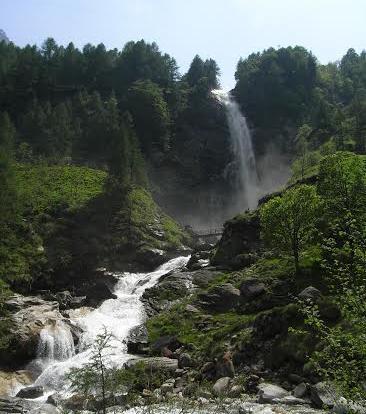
[212,89,259,213]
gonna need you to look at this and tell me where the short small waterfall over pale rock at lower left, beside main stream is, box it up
[37,321,75,365]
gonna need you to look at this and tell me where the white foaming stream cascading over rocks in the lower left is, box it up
[24,256,189,396]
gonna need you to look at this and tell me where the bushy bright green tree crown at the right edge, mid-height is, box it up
[318,152,366,289]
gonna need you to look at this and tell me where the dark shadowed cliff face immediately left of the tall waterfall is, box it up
[150,99,239,228]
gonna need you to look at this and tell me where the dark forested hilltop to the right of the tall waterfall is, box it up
[234,46,366,162]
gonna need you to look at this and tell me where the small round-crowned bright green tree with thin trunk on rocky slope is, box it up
[260,185,319,274]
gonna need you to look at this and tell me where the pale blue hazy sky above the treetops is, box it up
[0,0,366,88]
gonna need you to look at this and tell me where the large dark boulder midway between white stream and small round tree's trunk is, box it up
[198,283,240,312]
